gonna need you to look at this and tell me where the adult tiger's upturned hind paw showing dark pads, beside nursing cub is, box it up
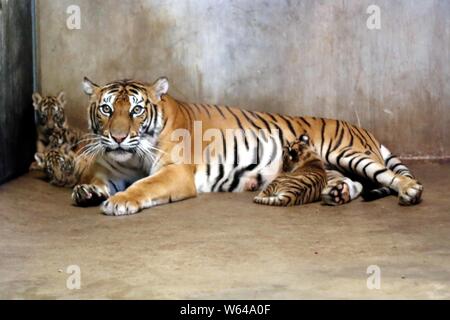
[322,180,363,206]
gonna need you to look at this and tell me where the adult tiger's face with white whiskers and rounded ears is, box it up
[83,78,169,162]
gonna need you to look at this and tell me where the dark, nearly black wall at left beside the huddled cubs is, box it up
[0,0,36,184]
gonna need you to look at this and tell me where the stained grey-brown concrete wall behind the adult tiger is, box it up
[37,0,450,157]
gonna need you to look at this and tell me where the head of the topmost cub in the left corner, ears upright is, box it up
[33,92,67,136]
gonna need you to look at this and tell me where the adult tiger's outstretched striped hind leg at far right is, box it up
[340,153,423,205]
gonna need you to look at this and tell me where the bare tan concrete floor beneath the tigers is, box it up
[0,164,450,299]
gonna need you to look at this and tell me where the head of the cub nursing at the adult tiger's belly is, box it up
[283,134,321,172]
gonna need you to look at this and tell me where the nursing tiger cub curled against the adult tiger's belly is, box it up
[254,134,327,206]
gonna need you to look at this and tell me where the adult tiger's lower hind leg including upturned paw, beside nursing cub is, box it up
[322,170,363,206]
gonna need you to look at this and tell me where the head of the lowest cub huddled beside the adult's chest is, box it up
[34,149,78,187]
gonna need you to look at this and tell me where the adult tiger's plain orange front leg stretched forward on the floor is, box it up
[102,164,197,216]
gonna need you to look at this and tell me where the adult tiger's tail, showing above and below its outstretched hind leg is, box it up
[361,145,414,201]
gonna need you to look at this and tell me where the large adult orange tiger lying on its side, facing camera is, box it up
[72,78,423,215]
